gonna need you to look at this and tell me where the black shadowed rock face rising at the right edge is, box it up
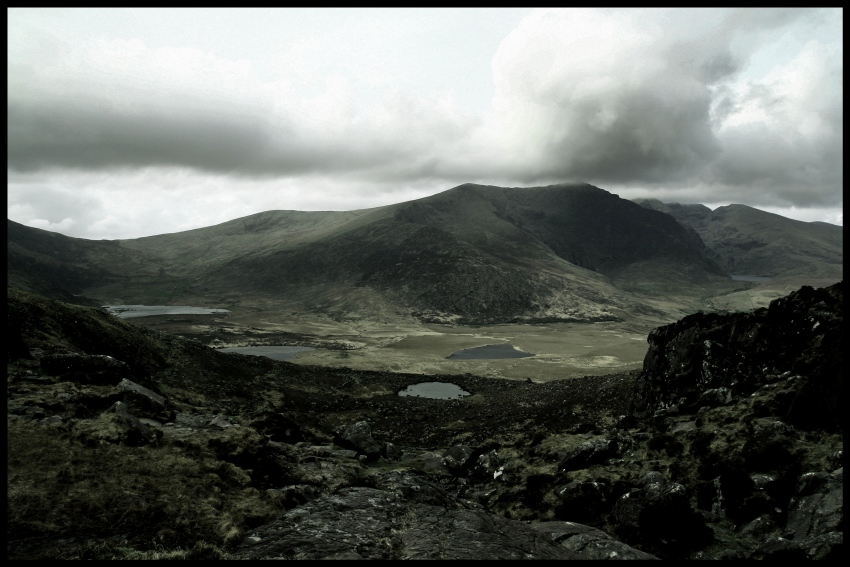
[634,283,844,428]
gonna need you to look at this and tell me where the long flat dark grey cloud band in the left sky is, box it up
[7,82,468,177]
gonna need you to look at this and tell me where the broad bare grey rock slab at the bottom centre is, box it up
[235,474,584,559]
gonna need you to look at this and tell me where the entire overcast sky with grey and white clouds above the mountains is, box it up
[7,9,844,239]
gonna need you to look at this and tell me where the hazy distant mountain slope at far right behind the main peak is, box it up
[635,199,844,281]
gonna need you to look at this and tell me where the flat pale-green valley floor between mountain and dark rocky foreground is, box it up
[126,278,834,382]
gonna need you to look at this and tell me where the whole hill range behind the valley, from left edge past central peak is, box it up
[8,184,840,324]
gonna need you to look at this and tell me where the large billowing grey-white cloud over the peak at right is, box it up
[484,6,843,211]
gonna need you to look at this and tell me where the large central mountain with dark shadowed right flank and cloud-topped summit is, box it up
[195,184,720,322]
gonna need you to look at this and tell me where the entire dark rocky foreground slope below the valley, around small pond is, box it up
[7,283,843,559]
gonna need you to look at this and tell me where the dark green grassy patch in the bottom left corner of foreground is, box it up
[7,419,280,559]
